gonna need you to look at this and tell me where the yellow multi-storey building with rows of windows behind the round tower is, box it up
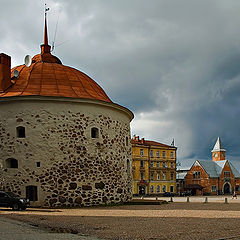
[131,136,177,195]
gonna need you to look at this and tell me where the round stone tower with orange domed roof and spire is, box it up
[0,15,133,207]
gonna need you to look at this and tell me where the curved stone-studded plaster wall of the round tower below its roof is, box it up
[0,98,132,207]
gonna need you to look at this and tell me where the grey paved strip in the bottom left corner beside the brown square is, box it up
[0,217,100,240]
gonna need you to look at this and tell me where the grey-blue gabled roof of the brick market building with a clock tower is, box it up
[193,160,240,178]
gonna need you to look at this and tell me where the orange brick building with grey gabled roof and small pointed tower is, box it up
[185,138,240,195]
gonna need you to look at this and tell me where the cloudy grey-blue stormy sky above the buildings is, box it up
[0,0,240,169]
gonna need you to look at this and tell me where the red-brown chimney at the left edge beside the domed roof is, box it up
[0,53,12,92]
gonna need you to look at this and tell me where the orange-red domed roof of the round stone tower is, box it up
[0,53,112,102]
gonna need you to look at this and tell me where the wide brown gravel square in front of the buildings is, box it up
[0,202,240,240]
